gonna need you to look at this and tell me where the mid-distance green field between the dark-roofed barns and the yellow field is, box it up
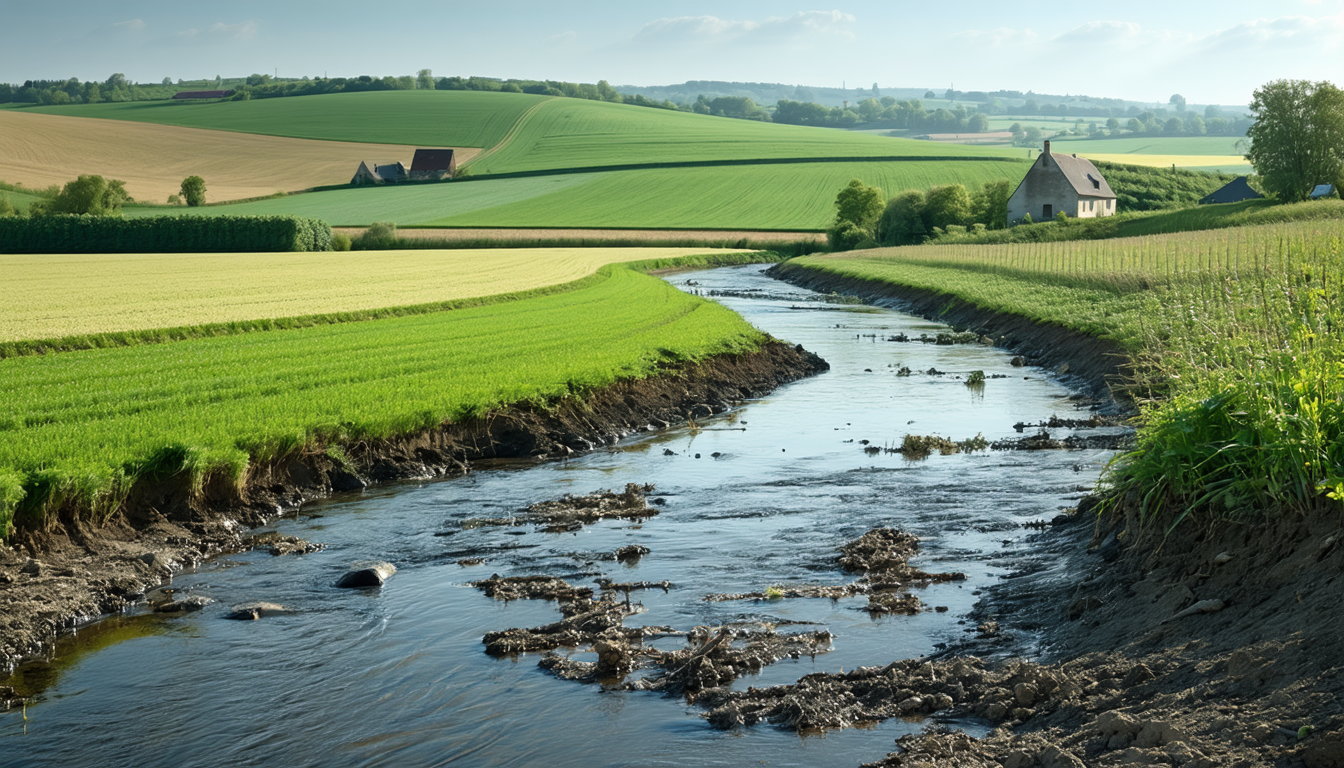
[126,160,1027,231]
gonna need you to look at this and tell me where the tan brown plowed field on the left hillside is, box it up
[0,110,480,203]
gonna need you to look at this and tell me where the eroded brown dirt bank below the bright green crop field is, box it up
[0,342,829,672]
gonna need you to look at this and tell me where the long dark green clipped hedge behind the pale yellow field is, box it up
[0,217,332,253]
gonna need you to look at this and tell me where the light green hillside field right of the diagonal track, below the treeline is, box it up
[472,98,1016,174]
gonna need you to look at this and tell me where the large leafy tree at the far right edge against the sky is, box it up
[1246,79,1344,200]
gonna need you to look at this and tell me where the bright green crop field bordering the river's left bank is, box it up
[0,258,763,533]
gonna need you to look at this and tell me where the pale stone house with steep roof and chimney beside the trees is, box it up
[1008,141,1116,225]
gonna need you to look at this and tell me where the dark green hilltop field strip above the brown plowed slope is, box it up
[18,90,546,149]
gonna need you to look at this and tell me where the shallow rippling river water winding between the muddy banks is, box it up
[0,266,1109,767]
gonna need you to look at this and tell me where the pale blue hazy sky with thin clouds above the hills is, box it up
[0,0,1344,105]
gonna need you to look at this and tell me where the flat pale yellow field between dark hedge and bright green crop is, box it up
[0,247,725,343]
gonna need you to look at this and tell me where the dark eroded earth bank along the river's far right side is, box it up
[766,262,1129,409]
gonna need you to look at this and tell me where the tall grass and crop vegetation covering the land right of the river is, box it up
[790,219,1344,529]
